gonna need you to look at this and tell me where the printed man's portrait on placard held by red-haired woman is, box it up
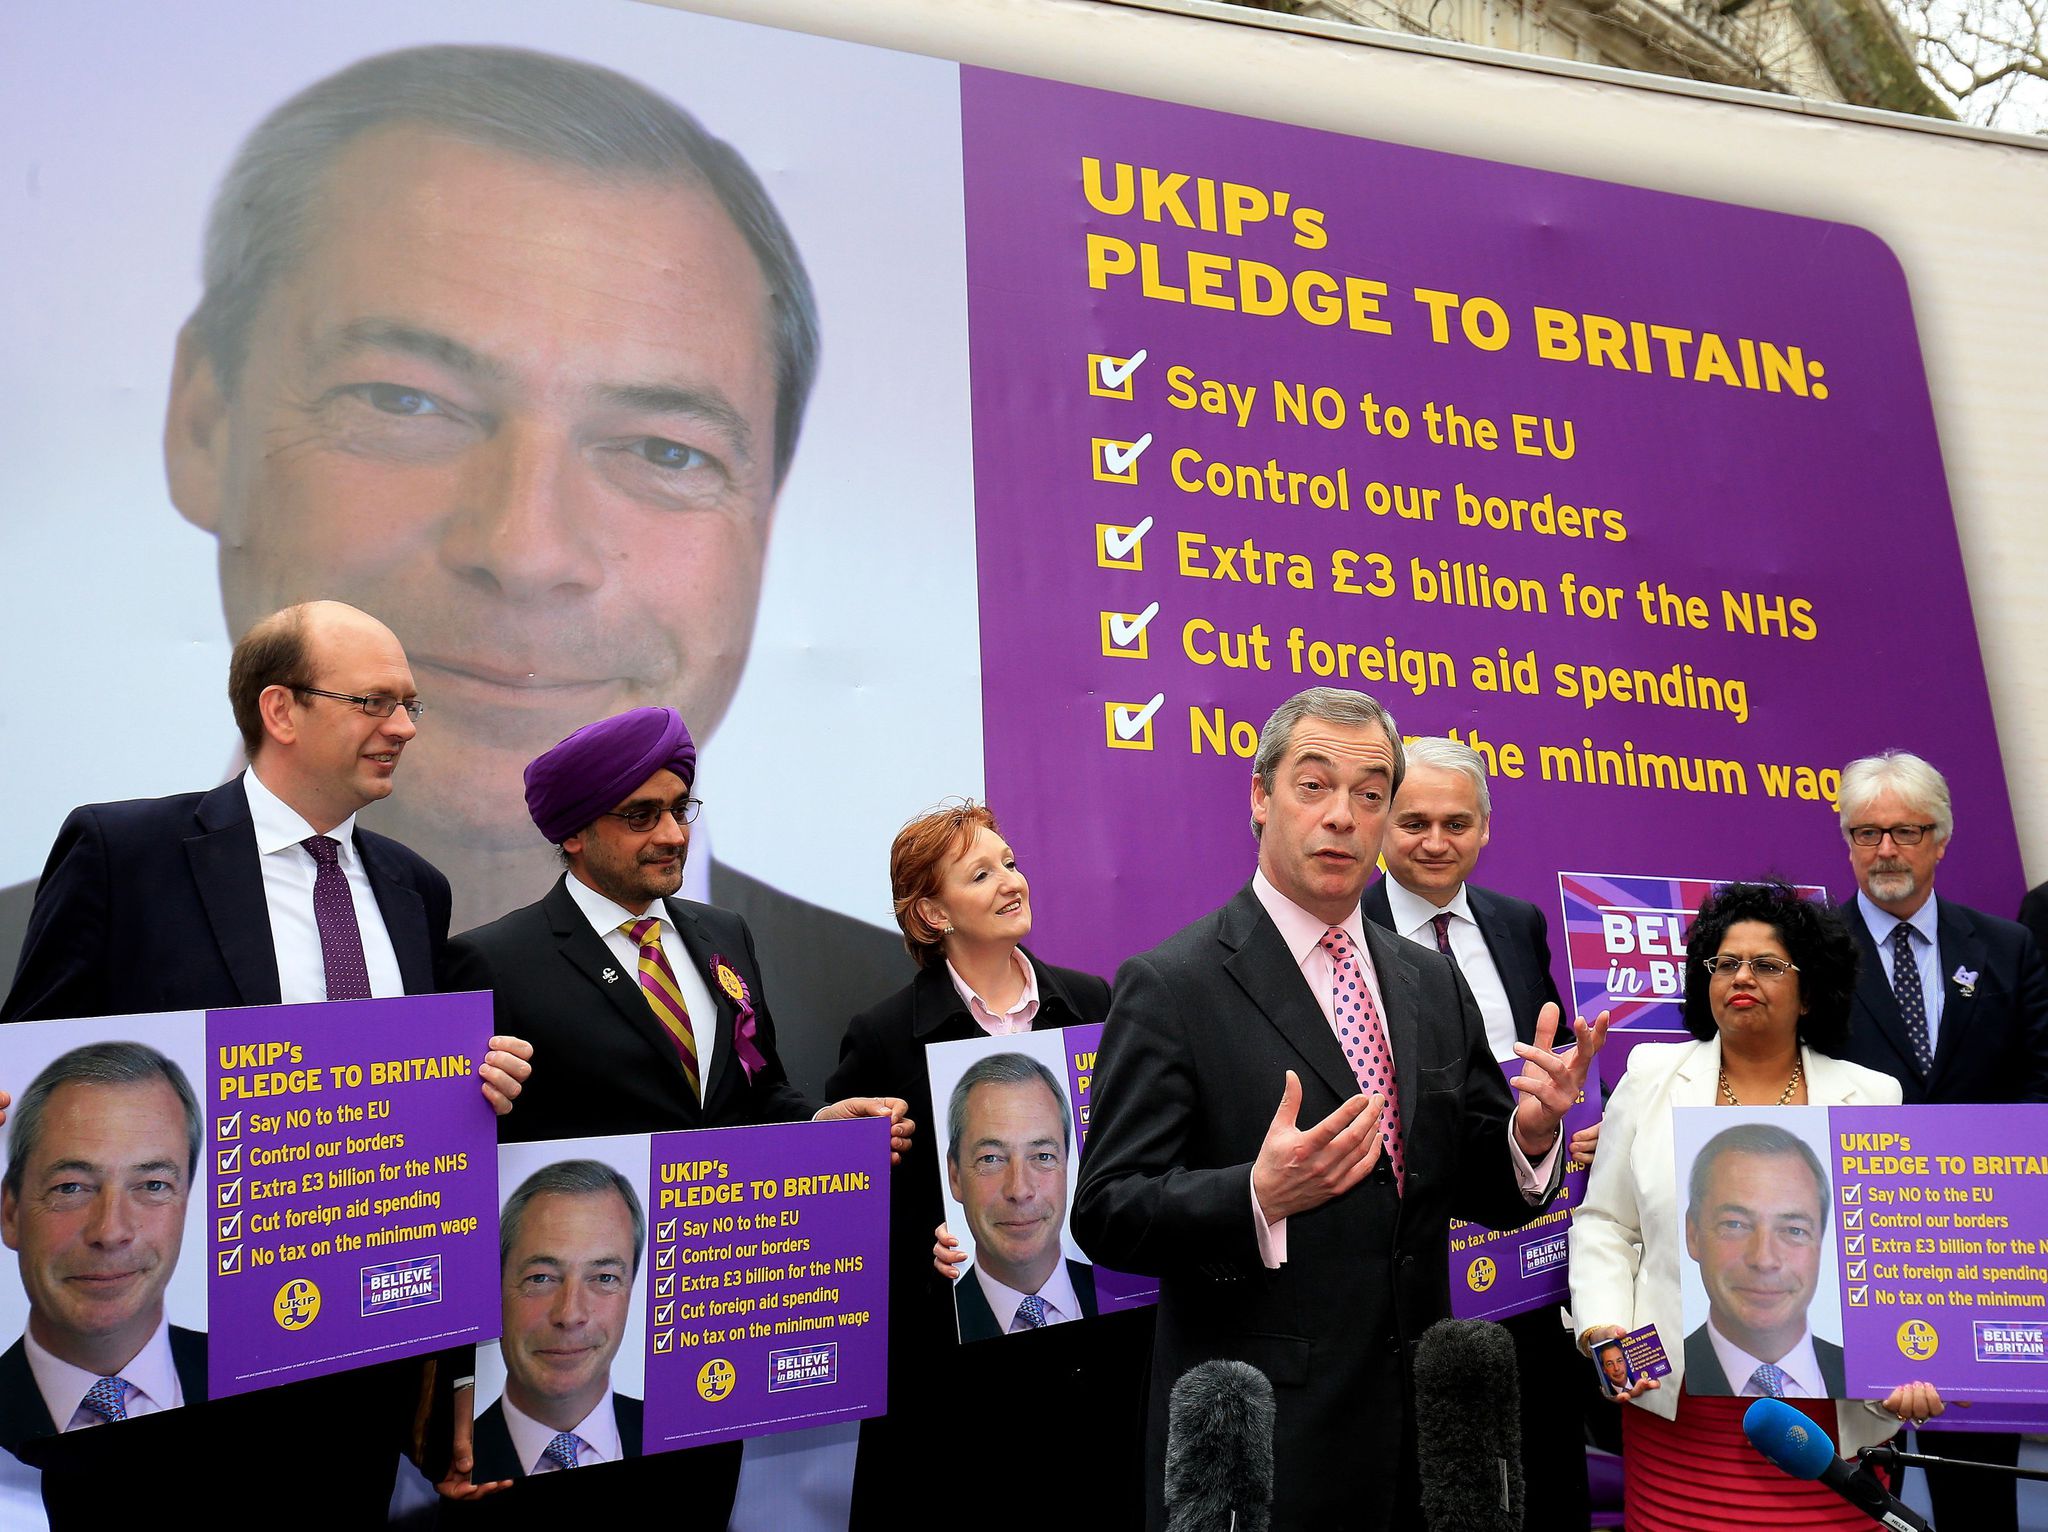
[946,1053,1096,1342]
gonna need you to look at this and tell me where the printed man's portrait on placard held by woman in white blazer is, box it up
[1686,1122,1849,1399]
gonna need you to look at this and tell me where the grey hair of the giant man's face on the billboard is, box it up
[190,45,819,483]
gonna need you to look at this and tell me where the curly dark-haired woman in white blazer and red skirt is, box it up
[1571,883,1942,1532]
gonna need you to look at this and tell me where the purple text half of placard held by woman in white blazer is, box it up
[1829,1106,2048,1400]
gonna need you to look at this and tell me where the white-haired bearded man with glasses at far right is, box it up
[1839,750,2048,1532]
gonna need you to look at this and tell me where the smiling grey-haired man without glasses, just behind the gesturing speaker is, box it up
[1360,735,1597,1532]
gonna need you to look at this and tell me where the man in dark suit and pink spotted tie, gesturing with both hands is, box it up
[1073,688,1606,1528]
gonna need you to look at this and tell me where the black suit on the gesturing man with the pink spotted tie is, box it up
[1073,885,1554,1528]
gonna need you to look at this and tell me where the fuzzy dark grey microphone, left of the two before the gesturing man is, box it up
[1165,1360,1274,1532]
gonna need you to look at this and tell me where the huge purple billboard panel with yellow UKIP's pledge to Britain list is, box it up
[961,70,2023,973]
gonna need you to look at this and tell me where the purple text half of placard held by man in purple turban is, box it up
[643,1118,889,1452]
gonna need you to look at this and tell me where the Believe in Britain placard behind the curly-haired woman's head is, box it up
[1556,873,1827,1028]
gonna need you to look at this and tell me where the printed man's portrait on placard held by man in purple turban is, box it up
[477,1159,647,1479]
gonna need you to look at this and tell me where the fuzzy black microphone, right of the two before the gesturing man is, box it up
[1415,1319,1522,1532]
